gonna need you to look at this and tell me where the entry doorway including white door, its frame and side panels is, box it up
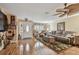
[18,20,33,39]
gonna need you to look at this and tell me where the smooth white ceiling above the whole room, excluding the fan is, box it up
[0,3,64,22]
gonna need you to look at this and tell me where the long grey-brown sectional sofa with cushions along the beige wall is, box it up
[39,31,75,44]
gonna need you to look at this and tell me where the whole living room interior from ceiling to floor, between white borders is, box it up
[0,3,79,55]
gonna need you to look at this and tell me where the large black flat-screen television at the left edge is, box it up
[0,11,8,32]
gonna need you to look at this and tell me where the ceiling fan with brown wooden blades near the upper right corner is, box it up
[54,3,79,17]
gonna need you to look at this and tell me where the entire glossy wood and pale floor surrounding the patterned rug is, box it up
[0,39,79,55]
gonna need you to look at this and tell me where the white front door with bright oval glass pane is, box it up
[21,22,33,39]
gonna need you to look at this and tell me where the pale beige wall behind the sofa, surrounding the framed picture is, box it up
[52,15,79,32]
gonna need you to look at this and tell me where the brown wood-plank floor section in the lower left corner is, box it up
[0,44,18,55]
